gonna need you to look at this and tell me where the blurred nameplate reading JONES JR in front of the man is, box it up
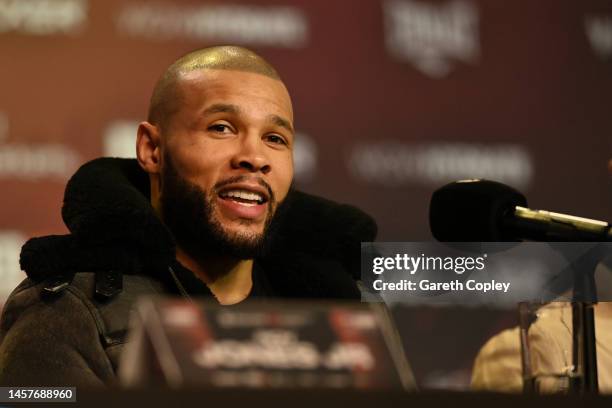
[119,299,414,389]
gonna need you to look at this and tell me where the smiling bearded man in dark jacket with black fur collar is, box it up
[0,47,376,386]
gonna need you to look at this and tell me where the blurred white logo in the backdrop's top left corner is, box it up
[0,0,87,35]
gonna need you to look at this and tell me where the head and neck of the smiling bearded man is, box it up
[137,48,294,304]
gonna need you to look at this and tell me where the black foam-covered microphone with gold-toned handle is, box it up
[429,179,612,242]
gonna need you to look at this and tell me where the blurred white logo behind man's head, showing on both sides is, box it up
[102,120,318,182]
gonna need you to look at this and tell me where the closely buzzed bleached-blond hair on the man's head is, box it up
[147,46,281,129]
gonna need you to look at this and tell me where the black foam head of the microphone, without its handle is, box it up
[429,179,527,242]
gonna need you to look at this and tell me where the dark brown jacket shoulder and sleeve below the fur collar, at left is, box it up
[0,272,167,386]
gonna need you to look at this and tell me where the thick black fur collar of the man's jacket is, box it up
[20,158,376,296]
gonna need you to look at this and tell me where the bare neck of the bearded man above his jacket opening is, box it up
[176,247,253,305]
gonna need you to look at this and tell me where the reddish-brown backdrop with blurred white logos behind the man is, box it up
[0,0,612,388]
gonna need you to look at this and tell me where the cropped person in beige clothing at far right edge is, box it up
[471,159,612,394]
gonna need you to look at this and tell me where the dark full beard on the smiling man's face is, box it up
[160,151,285,261]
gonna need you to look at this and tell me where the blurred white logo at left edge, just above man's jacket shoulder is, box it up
[0,230,26,307]
